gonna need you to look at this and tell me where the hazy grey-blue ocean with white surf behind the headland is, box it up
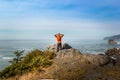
[0,39,120,70]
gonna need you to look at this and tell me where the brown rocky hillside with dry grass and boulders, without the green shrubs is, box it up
[1,44,120,80]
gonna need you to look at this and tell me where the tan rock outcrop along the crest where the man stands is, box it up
[48,43,109,65]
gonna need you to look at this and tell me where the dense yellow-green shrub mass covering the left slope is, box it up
[0,49,55,78]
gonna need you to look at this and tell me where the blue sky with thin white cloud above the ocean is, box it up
[0,0,120,40]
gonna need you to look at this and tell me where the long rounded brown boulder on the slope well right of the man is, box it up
[81,54,109,66]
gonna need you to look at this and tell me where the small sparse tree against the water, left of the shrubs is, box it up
[9,50,25,64]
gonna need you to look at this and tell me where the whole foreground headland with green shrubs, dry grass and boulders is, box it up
[0,43,120,80]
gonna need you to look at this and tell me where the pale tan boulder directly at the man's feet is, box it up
[56,48,82,58]
